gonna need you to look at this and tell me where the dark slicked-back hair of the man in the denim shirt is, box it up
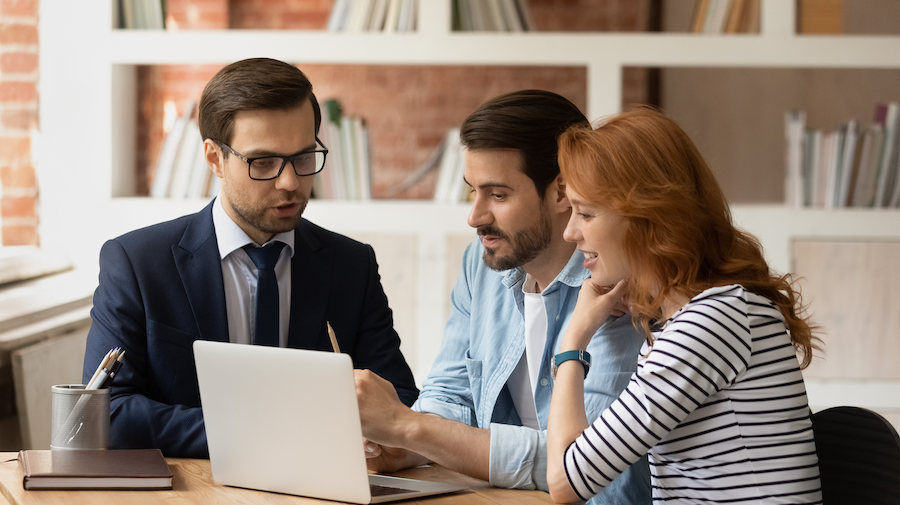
[460,89,590,198]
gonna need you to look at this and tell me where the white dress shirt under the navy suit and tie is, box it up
[213,197,294,347]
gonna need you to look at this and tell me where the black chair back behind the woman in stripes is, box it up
[812,407,900,505]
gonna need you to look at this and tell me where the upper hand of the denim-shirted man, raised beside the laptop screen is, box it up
[353,370,412,447]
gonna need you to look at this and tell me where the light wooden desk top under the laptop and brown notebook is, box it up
[0,452,552,505]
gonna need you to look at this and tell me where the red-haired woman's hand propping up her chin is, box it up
[560,279,628,352]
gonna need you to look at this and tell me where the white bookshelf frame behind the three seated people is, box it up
[38,0,900,398]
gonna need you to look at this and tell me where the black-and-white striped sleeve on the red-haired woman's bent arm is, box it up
[564,286,751,499]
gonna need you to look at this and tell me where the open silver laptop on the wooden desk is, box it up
[194,340,466,503]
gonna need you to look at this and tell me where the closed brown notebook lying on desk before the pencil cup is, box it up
[18,449,172,488]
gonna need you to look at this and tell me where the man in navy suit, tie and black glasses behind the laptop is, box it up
[83,58,418,457]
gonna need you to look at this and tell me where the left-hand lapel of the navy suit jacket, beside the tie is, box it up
[172,200,228,342]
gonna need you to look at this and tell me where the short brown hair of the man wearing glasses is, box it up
[199,58,322,145]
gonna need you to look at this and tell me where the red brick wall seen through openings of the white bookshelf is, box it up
[137,0,649,198]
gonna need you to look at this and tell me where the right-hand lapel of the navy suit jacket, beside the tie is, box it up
[288,219,334,350]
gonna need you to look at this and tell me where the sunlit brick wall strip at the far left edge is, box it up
[0,0,38,245]
